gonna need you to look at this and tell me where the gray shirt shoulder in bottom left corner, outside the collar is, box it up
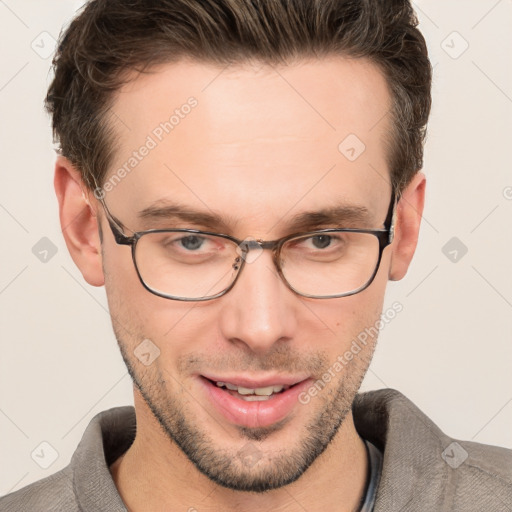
[0,466,79,512]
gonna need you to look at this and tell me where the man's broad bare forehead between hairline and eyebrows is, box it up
[106,57,390,231]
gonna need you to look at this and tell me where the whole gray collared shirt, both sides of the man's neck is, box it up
[0,389,512,512]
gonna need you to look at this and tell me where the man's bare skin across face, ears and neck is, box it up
[55,57,425,512]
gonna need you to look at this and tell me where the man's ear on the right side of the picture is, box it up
[389,172,427,281]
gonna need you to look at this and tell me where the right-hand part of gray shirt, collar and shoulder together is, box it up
[353,389,512,512]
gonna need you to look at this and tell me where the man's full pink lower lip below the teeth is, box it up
[199,376,311,428]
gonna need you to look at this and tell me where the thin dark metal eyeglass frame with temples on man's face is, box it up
[95,188,400,302]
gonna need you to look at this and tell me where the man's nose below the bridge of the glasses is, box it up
[218,250,298,354]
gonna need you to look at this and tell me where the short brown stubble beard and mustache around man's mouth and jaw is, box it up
[113,324,375,493]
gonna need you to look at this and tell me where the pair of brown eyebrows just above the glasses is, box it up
[137,199,373,234]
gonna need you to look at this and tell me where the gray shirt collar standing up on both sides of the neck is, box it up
[70,389,450,512]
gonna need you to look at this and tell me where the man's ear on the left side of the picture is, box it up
[53,156,105,286]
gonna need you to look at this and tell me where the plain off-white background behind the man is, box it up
[0,0,512,495]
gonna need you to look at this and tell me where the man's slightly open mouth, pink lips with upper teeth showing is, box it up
[199,375,312,428]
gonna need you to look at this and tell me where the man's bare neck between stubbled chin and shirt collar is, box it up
[110,393,369,512]
